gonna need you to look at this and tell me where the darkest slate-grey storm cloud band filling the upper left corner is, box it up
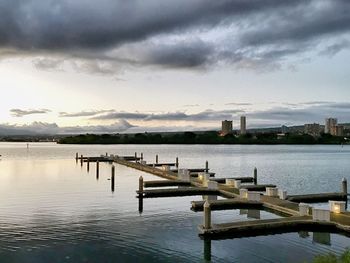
[0,0,303,50]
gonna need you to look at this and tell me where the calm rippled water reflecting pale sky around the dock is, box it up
[0,143,350,263]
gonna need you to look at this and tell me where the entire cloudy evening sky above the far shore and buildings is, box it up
[0,0,350,134]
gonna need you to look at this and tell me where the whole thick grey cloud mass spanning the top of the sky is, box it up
[0,0,350,75]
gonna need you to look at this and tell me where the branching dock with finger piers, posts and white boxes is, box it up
[76,153,350,239]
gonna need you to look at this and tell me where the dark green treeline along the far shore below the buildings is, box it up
[58,131,346,144]
